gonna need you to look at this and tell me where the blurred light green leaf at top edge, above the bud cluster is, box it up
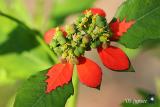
[51,0,96,26]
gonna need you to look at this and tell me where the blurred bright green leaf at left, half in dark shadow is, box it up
[0,16,53,84]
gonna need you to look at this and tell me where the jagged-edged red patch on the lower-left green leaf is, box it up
[46,63,73,93]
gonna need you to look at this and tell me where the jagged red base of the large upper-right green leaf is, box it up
[110,19,135,40]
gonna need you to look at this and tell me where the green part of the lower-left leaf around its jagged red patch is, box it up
[14,70,73,107]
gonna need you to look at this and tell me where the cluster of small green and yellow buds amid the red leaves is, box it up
[50,11,111,64]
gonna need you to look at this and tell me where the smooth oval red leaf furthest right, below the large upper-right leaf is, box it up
[98,46,130,71]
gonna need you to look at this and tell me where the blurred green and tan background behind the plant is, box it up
[0,0,160,107]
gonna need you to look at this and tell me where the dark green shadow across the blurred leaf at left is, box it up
[0,26,39,54]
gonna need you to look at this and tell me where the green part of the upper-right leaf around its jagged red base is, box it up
[116,0,160,48]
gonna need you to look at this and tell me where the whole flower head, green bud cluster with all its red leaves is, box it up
[44,8,135,93]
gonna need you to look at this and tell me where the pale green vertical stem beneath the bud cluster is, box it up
[66,66,79,107]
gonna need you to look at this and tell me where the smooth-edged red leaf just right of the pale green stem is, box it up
[77,57,102,88]
